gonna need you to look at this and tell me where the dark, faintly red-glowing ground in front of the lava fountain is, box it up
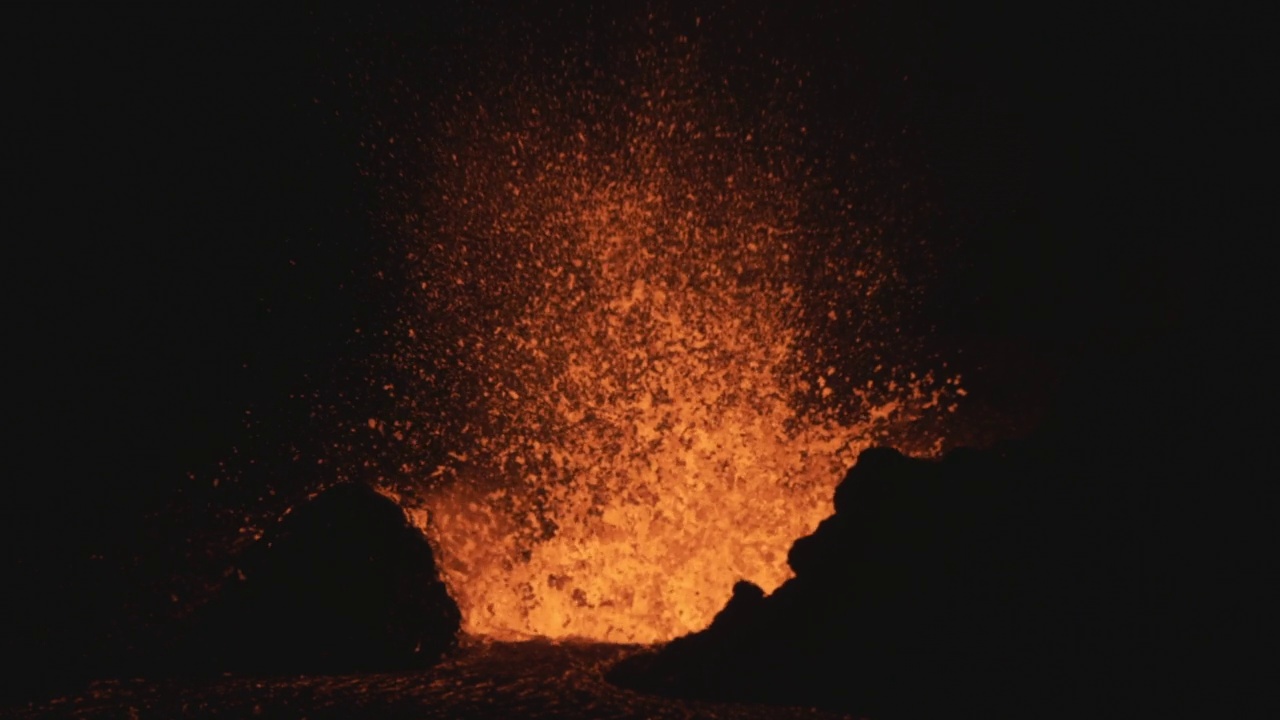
[10,642,841,719]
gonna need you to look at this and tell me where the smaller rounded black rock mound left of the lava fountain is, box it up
[183,484,461,673]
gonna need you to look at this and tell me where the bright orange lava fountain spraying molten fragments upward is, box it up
[369,46,963,642]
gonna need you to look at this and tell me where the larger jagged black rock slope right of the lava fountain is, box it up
[611,447,1140,717]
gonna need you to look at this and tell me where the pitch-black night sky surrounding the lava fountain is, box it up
[3,1,1276,696]
